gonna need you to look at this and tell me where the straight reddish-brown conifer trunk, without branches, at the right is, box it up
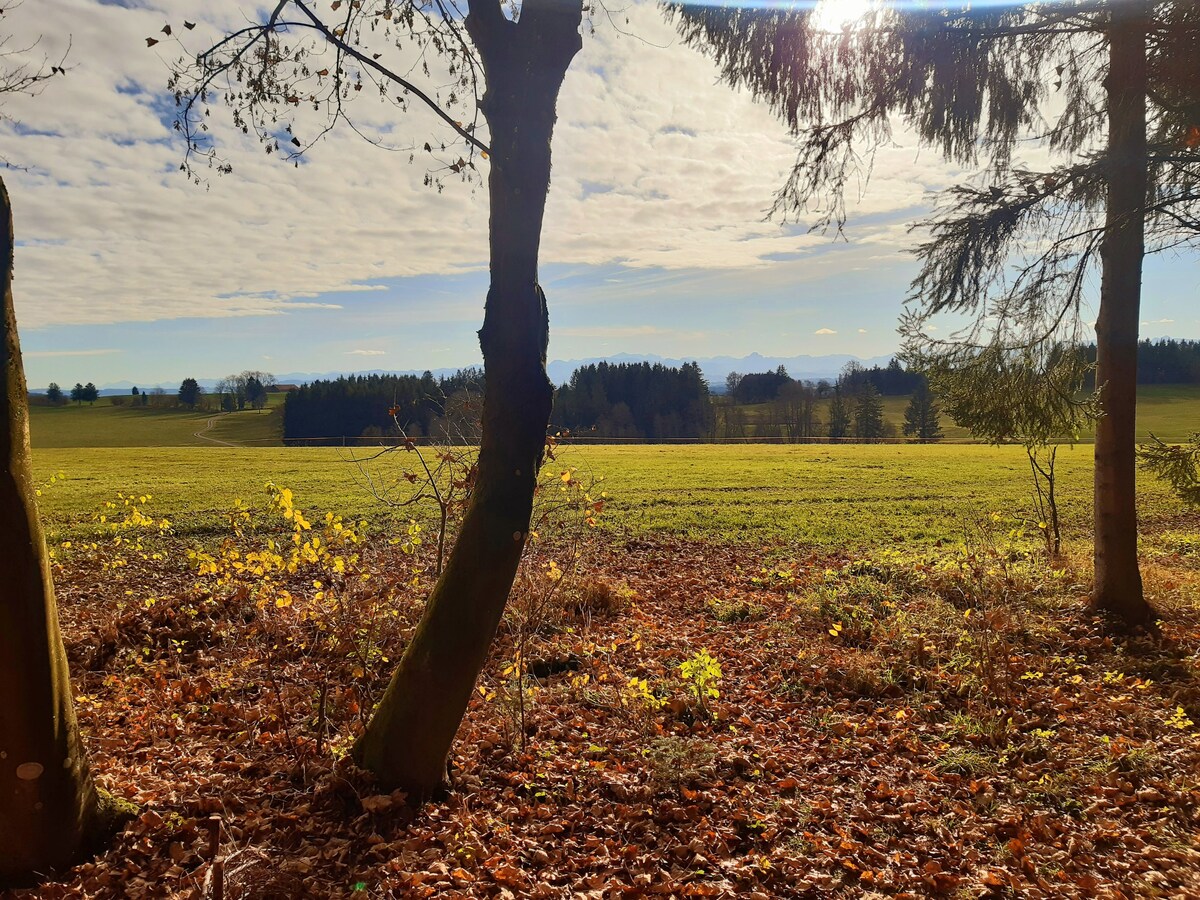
[1092,0,1156,626]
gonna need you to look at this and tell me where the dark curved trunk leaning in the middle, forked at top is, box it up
[354,0,582,799]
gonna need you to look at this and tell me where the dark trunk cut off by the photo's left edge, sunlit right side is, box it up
[0,180,101,886]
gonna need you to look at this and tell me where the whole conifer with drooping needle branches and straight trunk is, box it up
[668,0,1200,626]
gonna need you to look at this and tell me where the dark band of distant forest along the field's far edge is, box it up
[276,340,1200,443]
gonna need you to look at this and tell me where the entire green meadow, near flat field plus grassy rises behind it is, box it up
[30,385,1200,547]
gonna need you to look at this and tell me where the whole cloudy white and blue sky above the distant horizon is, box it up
[0,0,1200,389]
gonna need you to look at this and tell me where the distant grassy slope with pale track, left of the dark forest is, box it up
[29,394,284,449]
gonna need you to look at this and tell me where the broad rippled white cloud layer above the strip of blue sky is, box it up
[7,0,949,328]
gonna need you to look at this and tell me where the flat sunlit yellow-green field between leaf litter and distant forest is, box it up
[34,444,1182,547]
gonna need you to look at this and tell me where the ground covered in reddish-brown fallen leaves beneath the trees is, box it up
[14,522,1200,898]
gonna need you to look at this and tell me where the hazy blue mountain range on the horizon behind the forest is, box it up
[77,353,892,396]
